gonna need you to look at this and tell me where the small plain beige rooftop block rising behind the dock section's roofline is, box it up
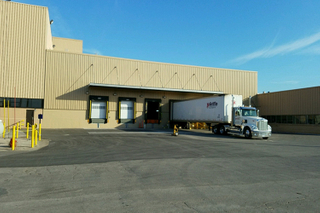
[52,37,82,53]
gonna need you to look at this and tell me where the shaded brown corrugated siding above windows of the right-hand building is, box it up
[256,87,320,115]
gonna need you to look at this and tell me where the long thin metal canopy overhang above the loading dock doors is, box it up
[89,83,224,94]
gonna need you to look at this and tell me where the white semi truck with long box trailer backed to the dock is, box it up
[170,95,272,139]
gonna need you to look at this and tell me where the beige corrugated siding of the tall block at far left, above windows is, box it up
[0,1,48,98]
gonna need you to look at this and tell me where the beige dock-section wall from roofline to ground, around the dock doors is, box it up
[43,50,257,128]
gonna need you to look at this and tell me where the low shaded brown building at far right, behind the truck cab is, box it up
[252,87,320,134]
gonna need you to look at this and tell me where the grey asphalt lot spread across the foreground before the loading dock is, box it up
[0,129,320,212]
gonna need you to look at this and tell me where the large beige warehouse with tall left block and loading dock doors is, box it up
[0,1,257,128]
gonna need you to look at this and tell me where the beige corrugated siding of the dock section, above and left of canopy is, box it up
[45,50,257,110]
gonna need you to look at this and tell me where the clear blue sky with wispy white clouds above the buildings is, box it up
[16,0,320,93]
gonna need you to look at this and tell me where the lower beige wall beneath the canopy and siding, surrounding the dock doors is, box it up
[42,88,206,129]
